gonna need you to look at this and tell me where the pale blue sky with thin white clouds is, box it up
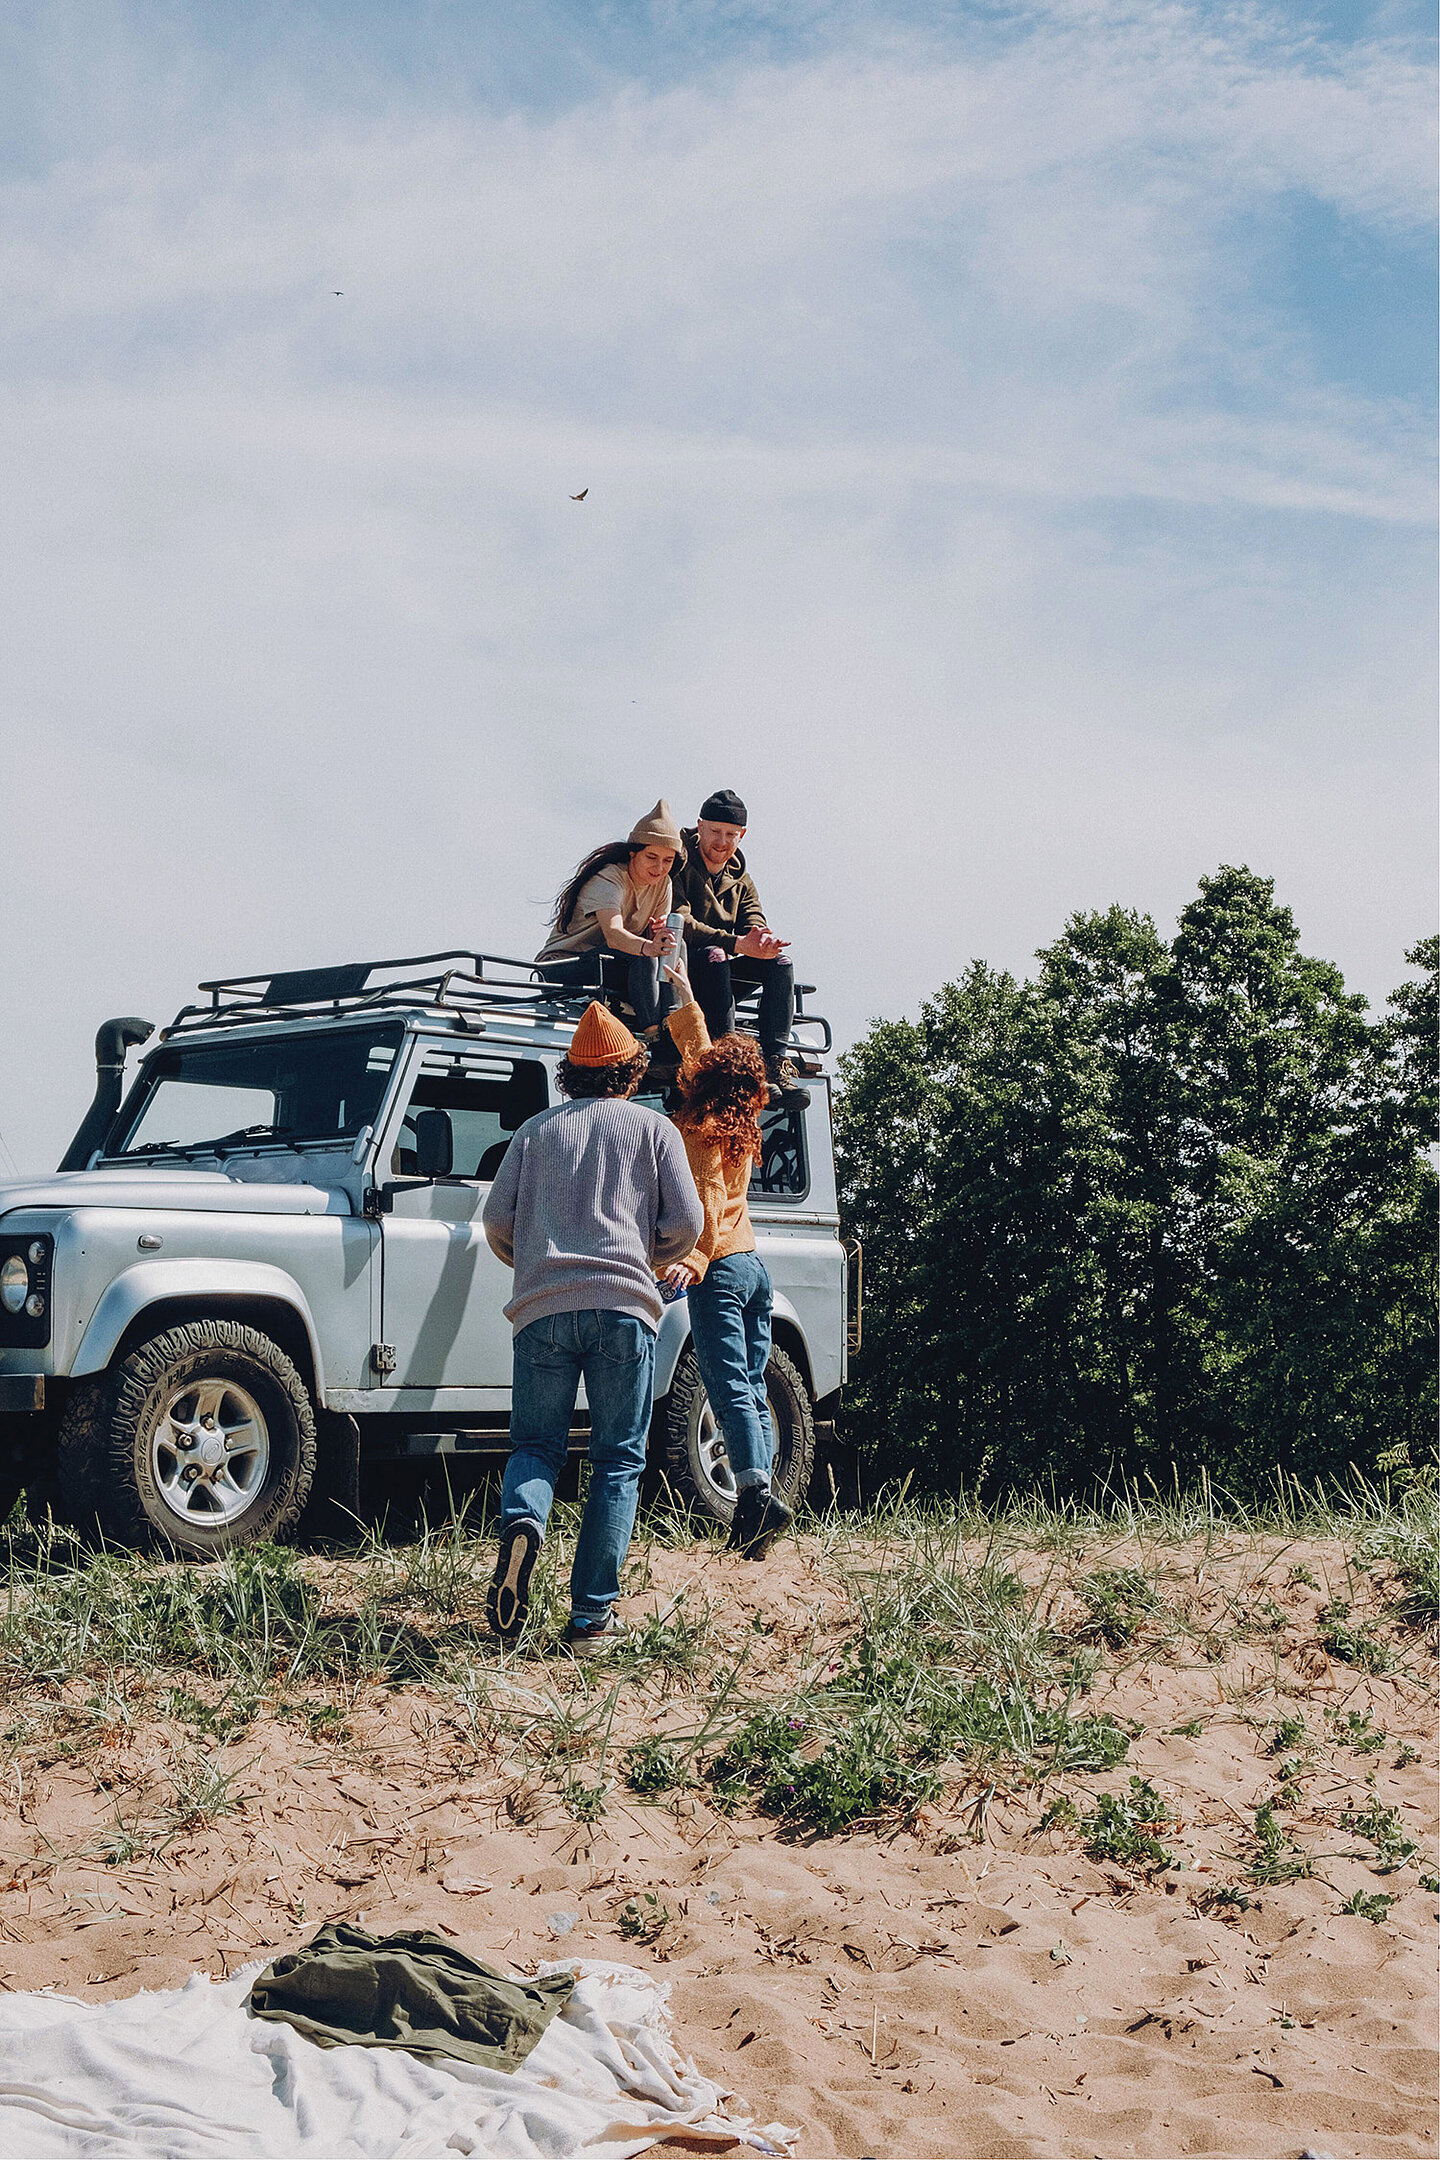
[0,0,1436,1169]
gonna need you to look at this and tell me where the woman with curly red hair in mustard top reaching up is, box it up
[665,950,792,1560]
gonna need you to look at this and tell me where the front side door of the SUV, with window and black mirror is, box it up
[380,1043,548,1391]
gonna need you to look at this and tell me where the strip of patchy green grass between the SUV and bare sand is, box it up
[0,1480,1434,1881]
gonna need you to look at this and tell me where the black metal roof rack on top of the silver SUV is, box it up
[160,946,831,1052]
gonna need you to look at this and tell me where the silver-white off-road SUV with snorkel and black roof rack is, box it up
[0,950,846,1555]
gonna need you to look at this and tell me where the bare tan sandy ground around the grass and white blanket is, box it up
[0,1540,1440,2160]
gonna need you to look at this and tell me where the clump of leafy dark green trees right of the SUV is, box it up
[838,868,1438,1486]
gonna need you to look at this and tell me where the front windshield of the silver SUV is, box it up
[106,1024,402,1158]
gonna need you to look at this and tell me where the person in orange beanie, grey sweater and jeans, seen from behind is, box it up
[484,1004,704,1657]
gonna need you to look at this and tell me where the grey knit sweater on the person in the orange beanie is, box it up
[484,1095,704,1335]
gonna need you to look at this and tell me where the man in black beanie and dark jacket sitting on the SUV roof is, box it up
[671,788,799,1095]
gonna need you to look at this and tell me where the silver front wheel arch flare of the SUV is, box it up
[71,1261,324,1404]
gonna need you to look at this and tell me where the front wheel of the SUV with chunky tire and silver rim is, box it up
[58,1320,315,1560]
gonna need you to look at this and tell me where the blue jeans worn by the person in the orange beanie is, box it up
[501,1311,654,1626]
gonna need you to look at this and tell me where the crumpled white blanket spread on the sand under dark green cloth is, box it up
[0,1961,790,2160]
